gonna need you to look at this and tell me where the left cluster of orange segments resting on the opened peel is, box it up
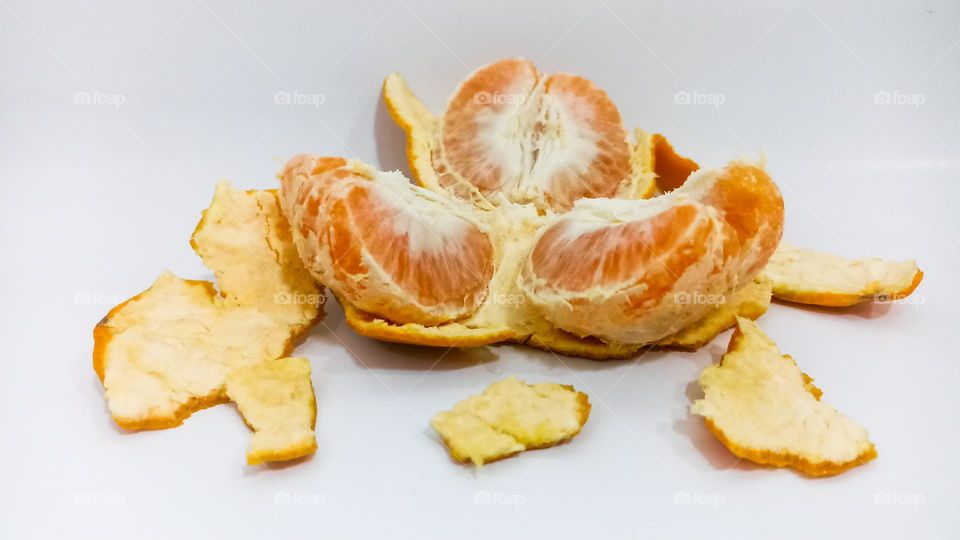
[281,157,493,324]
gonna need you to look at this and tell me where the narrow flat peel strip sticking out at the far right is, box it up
[761,242,923,307]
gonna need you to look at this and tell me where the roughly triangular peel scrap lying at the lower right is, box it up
[690,318,877,476]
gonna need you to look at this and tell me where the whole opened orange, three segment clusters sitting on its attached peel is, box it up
[280,59,916,358]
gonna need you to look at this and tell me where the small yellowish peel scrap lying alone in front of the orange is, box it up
[431,377,590,467]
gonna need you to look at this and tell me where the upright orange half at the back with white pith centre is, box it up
[434,59,631,211]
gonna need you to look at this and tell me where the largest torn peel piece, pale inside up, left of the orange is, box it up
[93,182,323,430]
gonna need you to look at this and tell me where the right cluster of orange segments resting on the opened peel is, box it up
[520,162,783,344]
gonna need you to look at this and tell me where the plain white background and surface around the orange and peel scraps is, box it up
[0,0,960,540]
